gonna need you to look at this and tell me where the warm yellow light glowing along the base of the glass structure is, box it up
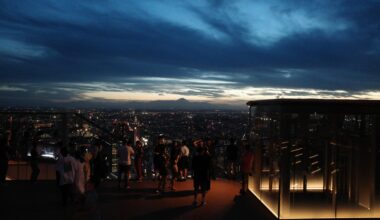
[248,176,380,219]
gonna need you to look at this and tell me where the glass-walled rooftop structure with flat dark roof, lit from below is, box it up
[247,99,380,219]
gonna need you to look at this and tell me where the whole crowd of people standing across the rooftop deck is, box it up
[0,131,254,211]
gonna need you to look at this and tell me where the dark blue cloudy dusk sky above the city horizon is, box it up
[0,0,380,106]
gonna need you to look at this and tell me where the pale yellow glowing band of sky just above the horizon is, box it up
[80,87,380,105]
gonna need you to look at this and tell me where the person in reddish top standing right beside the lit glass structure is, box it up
[240,144,254,194]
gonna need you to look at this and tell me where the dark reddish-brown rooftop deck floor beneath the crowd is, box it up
[0,179,274,220]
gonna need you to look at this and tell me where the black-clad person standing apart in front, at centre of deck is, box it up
[192,146,211,206]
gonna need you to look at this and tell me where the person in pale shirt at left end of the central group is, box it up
[118,140,135,189]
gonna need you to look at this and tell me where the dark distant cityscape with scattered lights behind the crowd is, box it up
[0,108,248,179]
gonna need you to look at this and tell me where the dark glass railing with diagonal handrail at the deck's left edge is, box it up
[0,111,119,180]
